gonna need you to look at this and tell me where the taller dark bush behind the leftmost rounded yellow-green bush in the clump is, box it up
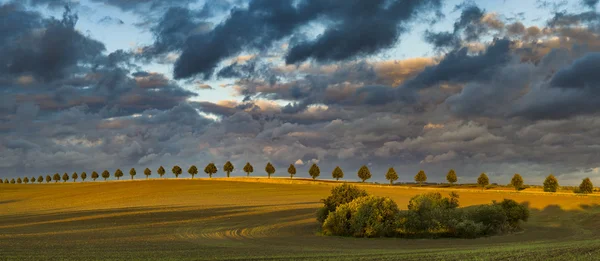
[317,184,368,223]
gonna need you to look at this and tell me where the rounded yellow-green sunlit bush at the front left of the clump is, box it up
[323,196,399,237]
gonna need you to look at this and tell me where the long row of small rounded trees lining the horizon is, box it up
[0,161,594,193]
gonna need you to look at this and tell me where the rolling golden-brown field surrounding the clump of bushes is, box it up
[0,178,600,260]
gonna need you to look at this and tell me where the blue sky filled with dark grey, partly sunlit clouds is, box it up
[0,0,600,185]
